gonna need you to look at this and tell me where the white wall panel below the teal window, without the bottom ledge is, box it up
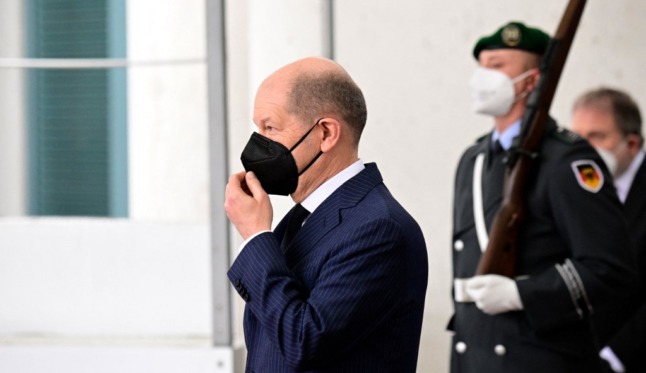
[0,218,212,338]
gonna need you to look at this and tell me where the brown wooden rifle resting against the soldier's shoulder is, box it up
[476,0,585,278]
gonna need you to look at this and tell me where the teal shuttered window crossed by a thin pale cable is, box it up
[26,0,128,216]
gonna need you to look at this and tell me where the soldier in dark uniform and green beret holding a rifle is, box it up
[449,22,637,373]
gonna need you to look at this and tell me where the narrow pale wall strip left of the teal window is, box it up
[0,0,27,216]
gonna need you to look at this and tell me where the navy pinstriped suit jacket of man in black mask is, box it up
[228,164,428,373]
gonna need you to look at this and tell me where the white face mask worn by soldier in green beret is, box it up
[469,66,532,117]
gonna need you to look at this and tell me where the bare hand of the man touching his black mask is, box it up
[224,171,274,240]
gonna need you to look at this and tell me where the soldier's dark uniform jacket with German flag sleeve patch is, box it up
[449,121,637,373]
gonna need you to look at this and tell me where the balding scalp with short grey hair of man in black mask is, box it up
[258,57,367,143]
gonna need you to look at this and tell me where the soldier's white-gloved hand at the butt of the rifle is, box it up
[466,275,523,315]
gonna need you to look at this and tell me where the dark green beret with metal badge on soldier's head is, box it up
[473,22,550,60]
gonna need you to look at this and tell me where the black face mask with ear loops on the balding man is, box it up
[240,119,323,196]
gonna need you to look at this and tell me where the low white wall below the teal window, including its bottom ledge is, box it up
[0,218,233,373]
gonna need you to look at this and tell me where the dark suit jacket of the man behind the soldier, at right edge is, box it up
[609,155,646,373]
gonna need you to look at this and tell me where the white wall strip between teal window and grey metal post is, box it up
[126,0,210,222]
